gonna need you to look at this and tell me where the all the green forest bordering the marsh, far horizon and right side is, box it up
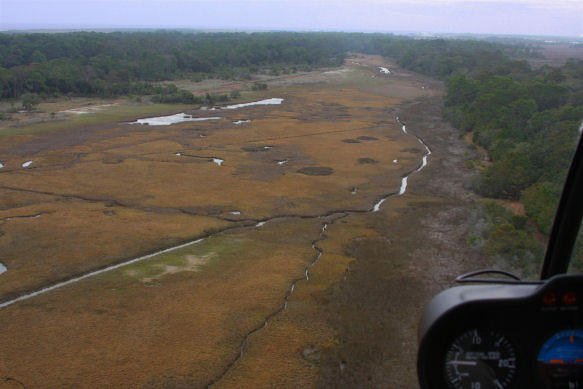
[0,32,583,270]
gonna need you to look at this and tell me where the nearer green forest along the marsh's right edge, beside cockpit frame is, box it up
[445,55,583,273]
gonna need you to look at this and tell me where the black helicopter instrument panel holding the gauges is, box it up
[417,275,583,389]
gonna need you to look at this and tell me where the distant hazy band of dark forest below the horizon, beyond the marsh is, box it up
[0,32,528,102]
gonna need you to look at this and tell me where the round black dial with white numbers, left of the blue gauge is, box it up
[444,329,517,389]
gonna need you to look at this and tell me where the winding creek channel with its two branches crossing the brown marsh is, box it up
[0,114,431,388]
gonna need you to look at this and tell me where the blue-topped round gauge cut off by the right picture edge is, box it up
[537,330,583,388]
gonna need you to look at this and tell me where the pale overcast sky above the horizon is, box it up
[0,0,583,37]
